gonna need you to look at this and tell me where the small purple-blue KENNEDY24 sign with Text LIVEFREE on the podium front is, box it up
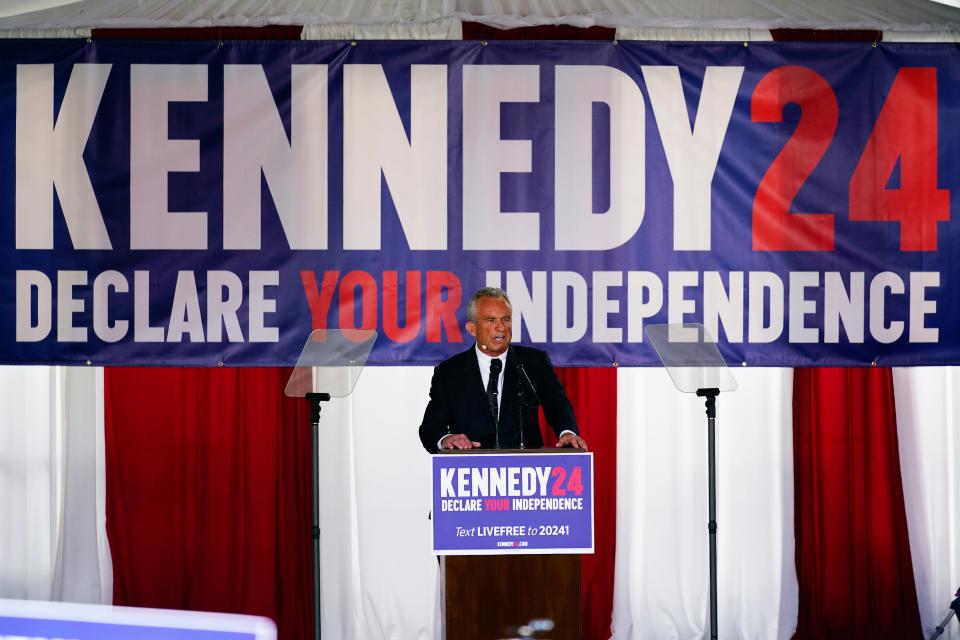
[432,449,593,555]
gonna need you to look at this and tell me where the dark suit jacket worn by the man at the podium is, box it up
[420,345,580,453]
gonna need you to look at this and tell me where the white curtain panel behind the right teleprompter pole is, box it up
[613,369,798,640]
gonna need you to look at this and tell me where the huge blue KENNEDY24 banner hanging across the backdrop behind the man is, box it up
[0,40,960,366]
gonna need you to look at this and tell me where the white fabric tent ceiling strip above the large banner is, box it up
[0,0,960,32]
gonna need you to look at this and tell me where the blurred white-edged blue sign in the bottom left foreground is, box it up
[0,600,277,640]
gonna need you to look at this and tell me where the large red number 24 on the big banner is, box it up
[751,66,950,251]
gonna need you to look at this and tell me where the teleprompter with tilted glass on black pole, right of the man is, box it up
[646,324,737,640]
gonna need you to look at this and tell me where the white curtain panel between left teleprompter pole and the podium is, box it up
[320,367,439,640]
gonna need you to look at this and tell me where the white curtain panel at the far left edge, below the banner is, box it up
[0,367,113,603]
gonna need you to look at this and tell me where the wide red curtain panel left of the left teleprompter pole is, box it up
[104,368,313,638]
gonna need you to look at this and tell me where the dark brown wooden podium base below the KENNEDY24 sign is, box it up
[440,554,580,640]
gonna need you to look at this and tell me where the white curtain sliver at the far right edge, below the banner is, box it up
[893,367,960,640]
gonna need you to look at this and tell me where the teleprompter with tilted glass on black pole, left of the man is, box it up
[283,329,377,640]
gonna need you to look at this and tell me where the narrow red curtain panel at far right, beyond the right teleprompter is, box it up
[793,368,922,640]
